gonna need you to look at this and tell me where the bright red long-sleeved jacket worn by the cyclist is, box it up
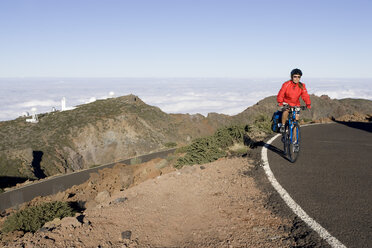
[276,80,311,107]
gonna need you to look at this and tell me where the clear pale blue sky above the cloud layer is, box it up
[0,0,372,78]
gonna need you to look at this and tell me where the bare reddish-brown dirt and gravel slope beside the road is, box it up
[1,158,326,247]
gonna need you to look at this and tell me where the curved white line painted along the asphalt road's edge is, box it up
[261,134,346,248]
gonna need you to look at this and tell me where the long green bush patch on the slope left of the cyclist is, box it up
[175,126,249,168]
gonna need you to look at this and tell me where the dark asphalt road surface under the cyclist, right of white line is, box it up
[268,123,372,247]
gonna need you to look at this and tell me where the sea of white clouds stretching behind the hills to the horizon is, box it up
[0,78,372,121]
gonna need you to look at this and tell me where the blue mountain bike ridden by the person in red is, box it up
[282,105,306,163]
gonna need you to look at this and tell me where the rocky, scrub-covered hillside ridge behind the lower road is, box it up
[0,95,372,182]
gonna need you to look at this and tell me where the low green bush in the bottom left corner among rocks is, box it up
[2,202,75,232]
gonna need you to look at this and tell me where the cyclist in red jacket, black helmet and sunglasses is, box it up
[276,68,311,133]
